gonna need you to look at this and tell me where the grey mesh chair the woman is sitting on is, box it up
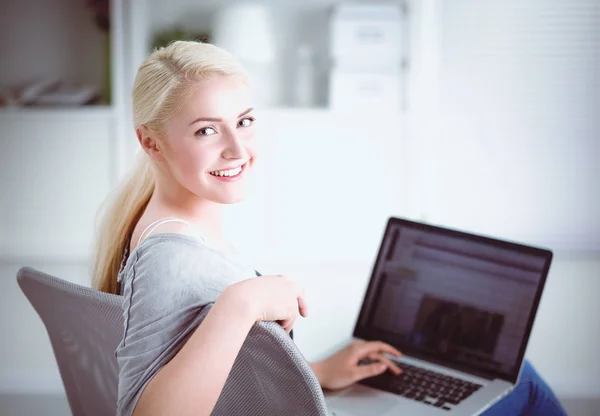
[17,267,328,416]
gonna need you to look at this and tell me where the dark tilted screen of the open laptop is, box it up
[354,218,552,383]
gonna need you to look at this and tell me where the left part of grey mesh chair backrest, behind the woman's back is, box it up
[17,267,123,416]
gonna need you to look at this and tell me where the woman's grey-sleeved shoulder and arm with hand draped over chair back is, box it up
[115,239,306,416]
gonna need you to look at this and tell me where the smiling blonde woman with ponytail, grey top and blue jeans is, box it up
[94,41,564,415]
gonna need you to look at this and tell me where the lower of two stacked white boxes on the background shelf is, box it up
[329,70,402,111]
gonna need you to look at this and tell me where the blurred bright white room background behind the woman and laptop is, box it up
[0,0,600,415]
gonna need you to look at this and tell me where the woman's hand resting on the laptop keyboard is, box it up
[311,341,402,390]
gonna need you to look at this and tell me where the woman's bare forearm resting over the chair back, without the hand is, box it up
[134,290,256,416]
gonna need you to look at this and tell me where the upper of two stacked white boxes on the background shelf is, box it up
[330,4,403,68]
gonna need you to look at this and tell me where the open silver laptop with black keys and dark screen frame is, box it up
[325,218,552,416]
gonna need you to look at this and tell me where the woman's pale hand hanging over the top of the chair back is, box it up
[221,275,308,332]
